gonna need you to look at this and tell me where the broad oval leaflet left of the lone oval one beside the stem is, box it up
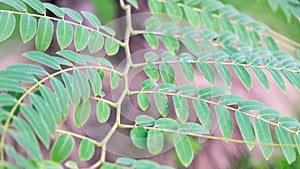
[74,100,91,127]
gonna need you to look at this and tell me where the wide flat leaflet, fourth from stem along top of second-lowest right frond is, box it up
[199,86,230,99]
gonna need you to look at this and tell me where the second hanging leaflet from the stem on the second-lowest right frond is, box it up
[154,93,169,117]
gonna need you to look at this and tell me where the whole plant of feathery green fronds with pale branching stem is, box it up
[0,0,300,169]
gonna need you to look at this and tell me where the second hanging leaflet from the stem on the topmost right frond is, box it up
[164,1,183,22]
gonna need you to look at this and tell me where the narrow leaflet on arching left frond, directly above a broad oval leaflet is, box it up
[73,69,91,102]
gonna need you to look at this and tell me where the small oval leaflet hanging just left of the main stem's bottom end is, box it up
[78,139,95,161]
